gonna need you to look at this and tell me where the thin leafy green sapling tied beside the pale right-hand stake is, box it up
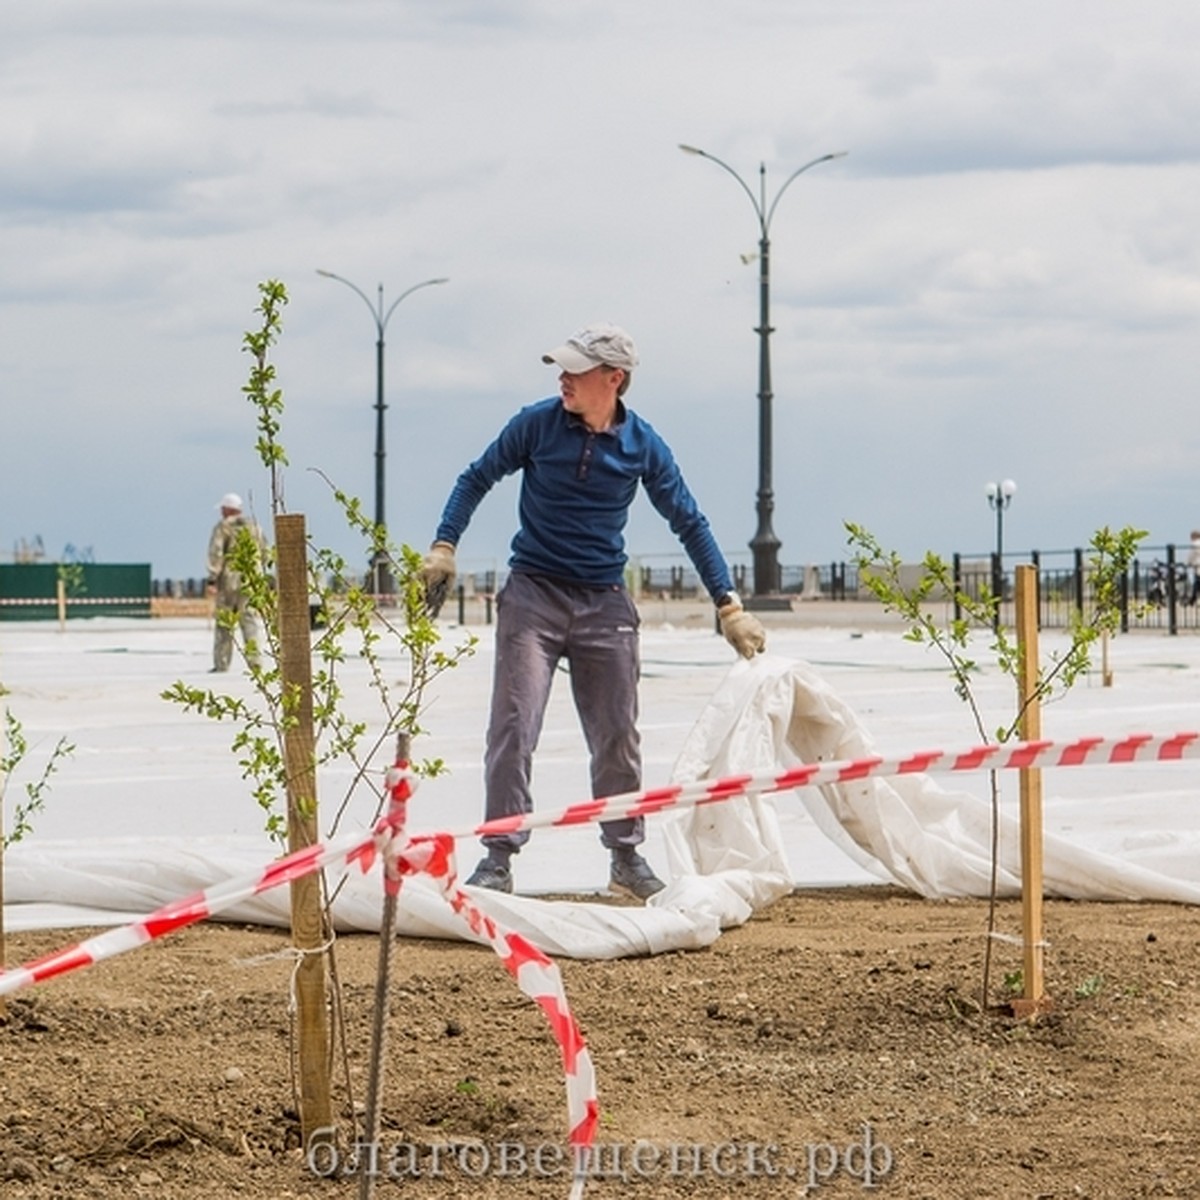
[845,521,1146,1010]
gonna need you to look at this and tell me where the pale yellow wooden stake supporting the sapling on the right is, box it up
[1013,564,1050,1016]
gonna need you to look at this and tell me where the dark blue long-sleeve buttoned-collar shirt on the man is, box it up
[437,396,733,600]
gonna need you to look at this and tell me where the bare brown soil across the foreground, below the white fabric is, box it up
[0,888,1200,1200]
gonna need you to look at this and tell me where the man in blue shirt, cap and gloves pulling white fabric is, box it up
[422,324,766,900]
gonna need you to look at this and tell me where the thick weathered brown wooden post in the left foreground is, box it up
[275,514,334,1152]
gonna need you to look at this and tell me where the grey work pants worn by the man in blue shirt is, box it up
[482,571,646,853]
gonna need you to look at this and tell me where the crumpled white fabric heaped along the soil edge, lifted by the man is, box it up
[4,655,1200,959]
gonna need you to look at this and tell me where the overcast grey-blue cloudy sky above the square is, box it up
[0,0,1200,578]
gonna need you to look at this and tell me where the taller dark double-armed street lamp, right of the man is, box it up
[679,143,847,596]
